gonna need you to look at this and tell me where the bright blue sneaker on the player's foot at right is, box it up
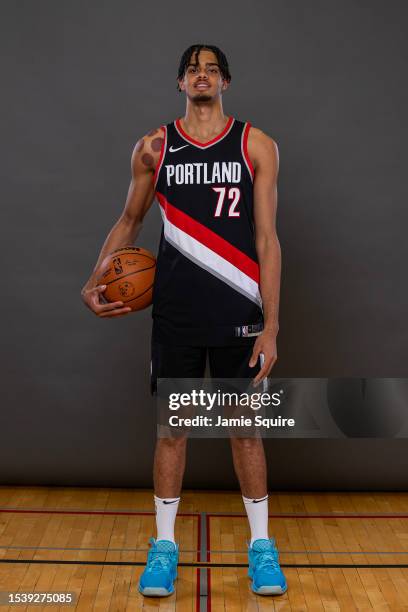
[248,538,288,595]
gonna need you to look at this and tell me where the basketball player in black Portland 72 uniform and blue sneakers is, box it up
[82,45,287,596]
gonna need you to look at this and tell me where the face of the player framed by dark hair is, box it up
[179,49,228,102]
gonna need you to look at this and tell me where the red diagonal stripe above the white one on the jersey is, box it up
[156,192,259,283]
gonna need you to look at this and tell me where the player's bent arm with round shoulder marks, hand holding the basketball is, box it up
[81,124,164,318]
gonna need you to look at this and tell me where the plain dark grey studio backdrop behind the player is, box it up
[0,0,408,489]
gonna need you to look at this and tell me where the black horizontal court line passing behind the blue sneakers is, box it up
[0,559,408,569]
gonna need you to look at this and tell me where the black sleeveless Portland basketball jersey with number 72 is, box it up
[152,117,263,346]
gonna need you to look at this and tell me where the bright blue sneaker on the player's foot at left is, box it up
[139,538,179,597]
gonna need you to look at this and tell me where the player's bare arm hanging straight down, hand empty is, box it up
[248,128,281,385]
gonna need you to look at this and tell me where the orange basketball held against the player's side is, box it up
[98,246,156,311]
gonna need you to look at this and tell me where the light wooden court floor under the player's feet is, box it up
[0,487,408,612]
